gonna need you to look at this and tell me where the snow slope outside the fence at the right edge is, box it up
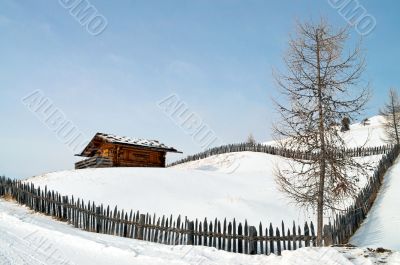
[351,158,400,251]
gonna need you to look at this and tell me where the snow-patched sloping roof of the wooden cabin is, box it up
[79,133,180,156]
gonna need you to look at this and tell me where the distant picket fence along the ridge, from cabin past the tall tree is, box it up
[168,143,393,167]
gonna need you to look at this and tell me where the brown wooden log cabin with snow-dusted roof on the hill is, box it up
[75,133,181,169]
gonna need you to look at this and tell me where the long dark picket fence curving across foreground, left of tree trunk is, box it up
[0,177,316,255]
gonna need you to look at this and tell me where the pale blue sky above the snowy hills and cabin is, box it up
[0,0,400,177]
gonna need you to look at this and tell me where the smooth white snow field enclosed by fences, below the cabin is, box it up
[28,152,381,226]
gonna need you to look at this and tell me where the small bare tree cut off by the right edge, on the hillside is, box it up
[380,88,400,144]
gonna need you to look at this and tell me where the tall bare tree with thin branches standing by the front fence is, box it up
[274,20,369,245]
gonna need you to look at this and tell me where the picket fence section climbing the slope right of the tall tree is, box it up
[324,145,400,245]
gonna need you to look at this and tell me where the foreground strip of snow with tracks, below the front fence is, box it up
[0,199,400,265]
